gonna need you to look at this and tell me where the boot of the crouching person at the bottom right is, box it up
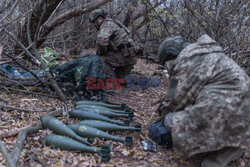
[201,147,243,167]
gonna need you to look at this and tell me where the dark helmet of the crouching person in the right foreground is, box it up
[158,36,189,65]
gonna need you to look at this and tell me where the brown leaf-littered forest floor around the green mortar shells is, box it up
[0,60,250,167]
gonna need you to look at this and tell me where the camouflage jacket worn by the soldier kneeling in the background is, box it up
[96,18,136,67]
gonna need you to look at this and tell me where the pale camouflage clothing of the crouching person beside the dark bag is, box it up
[159,35,250,157]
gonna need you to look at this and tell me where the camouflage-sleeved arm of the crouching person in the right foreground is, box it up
[160,58,213,119]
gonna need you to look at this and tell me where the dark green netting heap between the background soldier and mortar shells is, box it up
[52,54,106,101]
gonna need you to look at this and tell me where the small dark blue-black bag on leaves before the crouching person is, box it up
[149,119,173,148]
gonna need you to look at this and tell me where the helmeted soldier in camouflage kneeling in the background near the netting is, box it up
[89,9,139,78]
